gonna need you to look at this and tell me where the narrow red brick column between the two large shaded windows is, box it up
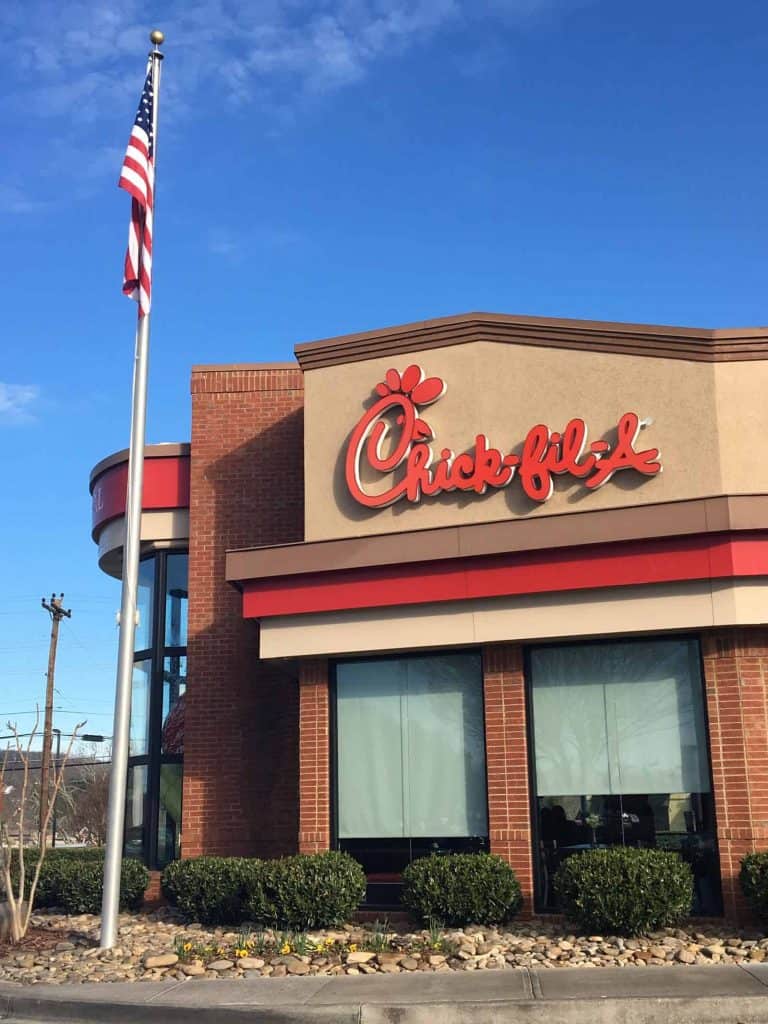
[482,644,534,914]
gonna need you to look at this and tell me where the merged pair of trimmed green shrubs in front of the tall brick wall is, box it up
[162,851,366,930]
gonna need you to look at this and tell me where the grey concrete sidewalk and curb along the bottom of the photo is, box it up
[0,965,768,1024]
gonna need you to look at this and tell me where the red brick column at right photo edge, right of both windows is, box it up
[702,629,768,920]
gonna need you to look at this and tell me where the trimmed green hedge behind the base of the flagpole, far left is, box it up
[6,847,150,913]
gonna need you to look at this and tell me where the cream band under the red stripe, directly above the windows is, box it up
[260,577,768,658]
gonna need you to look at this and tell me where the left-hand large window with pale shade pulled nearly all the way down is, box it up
[335,652,487,905]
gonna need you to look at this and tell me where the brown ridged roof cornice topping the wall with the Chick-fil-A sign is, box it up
[294,312,768,371]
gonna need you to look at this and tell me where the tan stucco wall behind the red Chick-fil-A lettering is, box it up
[305,342,768,541]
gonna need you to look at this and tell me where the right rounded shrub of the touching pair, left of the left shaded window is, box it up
[253,850,366,931]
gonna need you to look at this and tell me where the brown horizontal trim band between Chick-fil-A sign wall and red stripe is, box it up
[225,495,768,584]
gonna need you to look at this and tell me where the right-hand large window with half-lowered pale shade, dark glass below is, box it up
[529,639,721,913]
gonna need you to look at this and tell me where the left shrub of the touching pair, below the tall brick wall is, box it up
[161,857,263,925]
